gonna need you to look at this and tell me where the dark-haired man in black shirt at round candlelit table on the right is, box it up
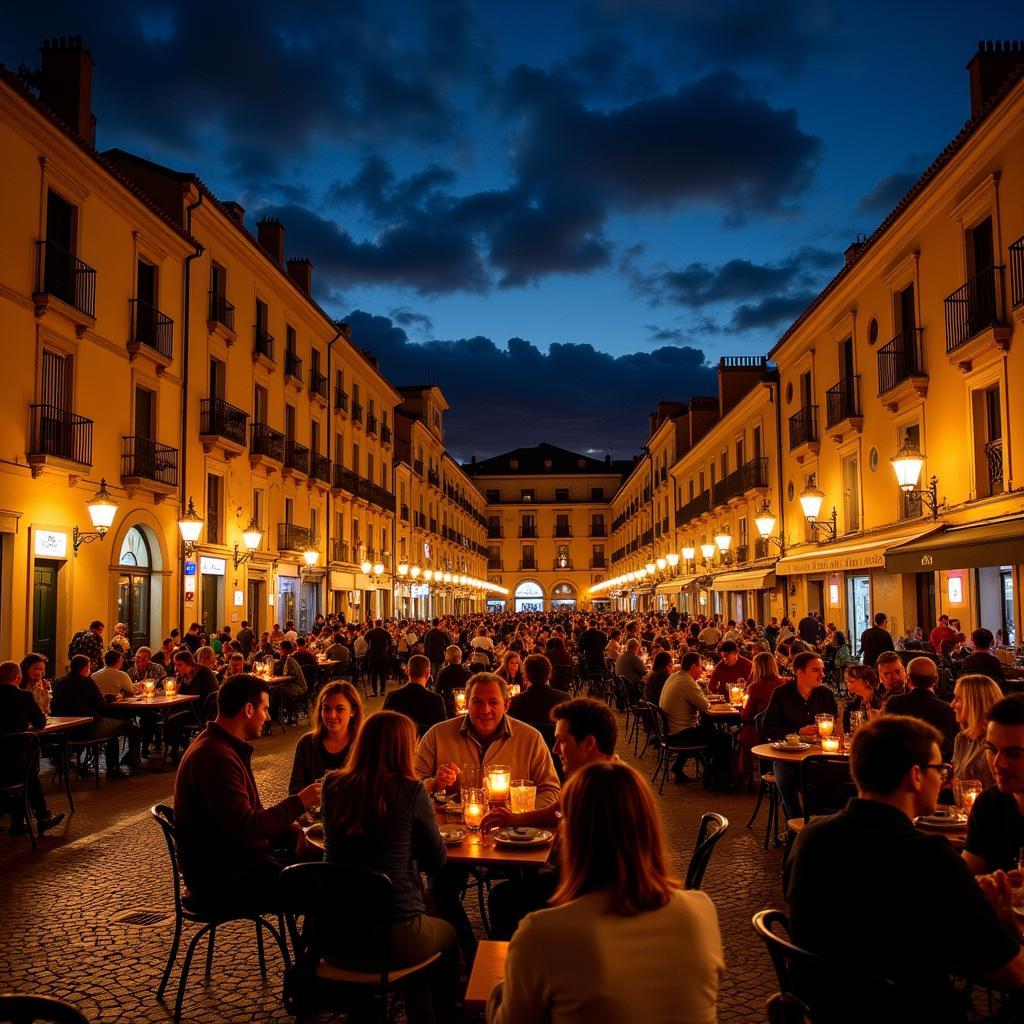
[762,650,837,818]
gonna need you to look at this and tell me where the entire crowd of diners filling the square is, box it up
[0,609,1024,1024]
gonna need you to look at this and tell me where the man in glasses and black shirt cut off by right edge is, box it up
[964,693,1024,874]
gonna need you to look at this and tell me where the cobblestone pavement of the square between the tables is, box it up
[0,699,783,1024]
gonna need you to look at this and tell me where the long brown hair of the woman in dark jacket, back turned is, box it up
[321,711,416,836]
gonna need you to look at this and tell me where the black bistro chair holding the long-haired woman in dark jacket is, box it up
[281,862,440,1024]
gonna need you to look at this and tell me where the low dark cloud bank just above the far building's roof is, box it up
[347,310,715,458]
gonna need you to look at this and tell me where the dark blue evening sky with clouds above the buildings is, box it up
[0,0,1024,458]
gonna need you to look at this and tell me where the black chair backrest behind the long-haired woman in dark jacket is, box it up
[281,861,393,987]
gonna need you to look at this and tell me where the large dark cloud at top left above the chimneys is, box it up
[0,0,487,182]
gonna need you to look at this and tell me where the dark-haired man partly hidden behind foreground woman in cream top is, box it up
[480,697,618,940]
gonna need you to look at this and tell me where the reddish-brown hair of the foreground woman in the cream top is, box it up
[551,761,681,918]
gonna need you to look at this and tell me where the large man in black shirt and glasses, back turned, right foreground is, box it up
[785,715,1024,1022]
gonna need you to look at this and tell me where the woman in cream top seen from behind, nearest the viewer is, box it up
[486,761,725,1024]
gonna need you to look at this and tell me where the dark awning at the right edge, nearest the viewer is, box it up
[886,515,1024,572]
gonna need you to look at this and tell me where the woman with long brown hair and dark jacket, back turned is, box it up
[321,711,459,1024]
